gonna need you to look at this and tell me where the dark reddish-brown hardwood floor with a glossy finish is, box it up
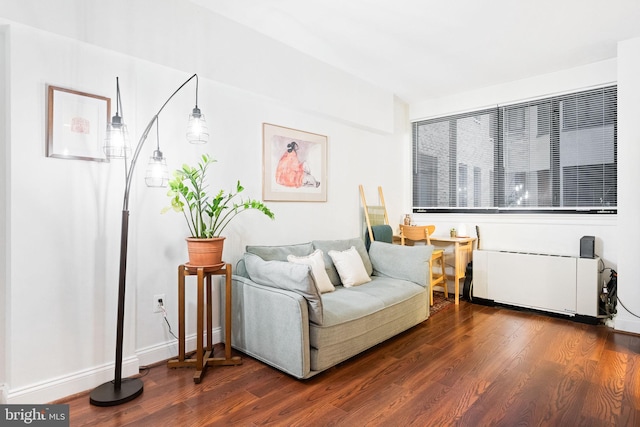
[56,302,640,427]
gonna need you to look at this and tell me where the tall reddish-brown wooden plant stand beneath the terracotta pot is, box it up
[167,263,242,384]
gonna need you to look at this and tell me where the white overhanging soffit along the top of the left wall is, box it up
[0,0,394,133]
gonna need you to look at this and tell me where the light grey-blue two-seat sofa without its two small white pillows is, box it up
[220,238,433,378]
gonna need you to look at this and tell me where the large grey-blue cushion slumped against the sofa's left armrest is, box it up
[244,253,323,325]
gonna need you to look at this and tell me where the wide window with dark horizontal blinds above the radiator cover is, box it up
[413,86,617,213]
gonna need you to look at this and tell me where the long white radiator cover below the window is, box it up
[473,250,602,317]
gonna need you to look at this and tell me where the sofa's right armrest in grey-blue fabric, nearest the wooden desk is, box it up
[369,241,433,287]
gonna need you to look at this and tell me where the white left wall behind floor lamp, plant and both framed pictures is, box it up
[0,1,409,403]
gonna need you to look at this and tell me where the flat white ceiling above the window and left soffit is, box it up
[191,0,640,103]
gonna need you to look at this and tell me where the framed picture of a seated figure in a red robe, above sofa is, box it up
[262,123,327,202]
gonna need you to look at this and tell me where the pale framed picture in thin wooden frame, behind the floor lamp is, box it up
[47,86,111,162]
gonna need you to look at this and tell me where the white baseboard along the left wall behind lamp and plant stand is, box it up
[5,327,222,404]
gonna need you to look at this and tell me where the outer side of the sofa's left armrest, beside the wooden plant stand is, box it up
[220,275,311,378]
